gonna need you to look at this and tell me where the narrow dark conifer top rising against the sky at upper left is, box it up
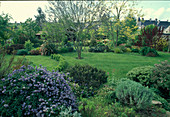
[34,7,46,30]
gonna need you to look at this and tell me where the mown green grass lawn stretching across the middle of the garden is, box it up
[13,52,170,78]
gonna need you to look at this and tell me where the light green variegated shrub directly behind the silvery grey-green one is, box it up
[126,66,153,87]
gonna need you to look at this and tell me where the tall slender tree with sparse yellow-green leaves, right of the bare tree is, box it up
[101,0,143,46]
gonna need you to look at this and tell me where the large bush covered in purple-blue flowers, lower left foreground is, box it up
[0,66,77,117]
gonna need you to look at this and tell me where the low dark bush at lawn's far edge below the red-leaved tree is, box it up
[140,47,159,57]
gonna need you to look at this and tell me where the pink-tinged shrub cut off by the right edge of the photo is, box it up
[151,61,170,99]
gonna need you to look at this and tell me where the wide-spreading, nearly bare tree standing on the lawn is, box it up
[48,1,105,59]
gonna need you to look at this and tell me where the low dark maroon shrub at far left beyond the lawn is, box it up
[6,44,24,54]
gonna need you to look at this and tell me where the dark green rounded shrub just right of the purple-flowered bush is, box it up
[66,64,107,97]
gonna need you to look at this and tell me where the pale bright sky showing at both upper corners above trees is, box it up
[0,0,170,22]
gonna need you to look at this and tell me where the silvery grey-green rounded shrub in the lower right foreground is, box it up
[116,80,153,109]
